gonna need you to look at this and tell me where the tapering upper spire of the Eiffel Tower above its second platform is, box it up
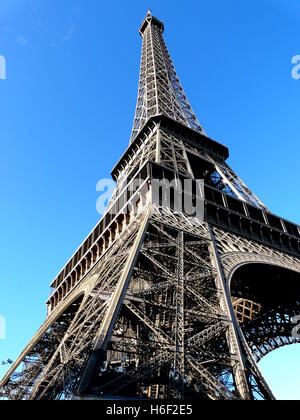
[131,10,205,141]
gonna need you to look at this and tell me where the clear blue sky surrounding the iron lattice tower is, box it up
[0,0,300,399]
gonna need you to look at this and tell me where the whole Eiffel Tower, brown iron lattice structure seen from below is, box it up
[0,12,300,400]
